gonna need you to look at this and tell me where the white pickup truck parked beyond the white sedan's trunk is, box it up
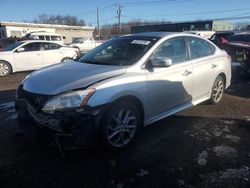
[70,37,102,52]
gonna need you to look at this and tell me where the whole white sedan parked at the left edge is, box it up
[0,40,79,76]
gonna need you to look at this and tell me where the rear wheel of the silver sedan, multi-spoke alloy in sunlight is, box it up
[210,75,225,104]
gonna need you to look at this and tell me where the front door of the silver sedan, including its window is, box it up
[147,37,193,116]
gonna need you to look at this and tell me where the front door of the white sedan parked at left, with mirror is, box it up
[14,42,43,71]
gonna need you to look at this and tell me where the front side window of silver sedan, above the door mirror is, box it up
[151,37,188,64]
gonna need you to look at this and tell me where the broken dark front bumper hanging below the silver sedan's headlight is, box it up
[15,99,99,149]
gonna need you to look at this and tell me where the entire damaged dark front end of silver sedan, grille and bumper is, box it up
[15,85,101,150]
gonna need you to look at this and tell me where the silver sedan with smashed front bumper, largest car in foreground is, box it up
[16,32,231,150]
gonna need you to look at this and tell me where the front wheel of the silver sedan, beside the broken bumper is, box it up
[101,101,141,150]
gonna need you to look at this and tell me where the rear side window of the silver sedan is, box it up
[187,37,215,59]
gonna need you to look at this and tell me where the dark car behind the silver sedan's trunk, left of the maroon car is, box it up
[209,31,235,48]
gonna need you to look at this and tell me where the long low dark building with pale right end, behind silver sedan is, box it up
[131,20,234,33]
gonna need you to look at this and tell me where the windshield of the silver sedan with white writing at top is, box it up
[80,36,159,66]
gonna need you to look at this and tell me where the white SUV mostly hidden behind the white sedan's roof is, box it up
[25,31,64,44]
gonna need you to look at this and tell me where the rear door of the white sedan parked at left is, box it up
[42,42,63,66]
